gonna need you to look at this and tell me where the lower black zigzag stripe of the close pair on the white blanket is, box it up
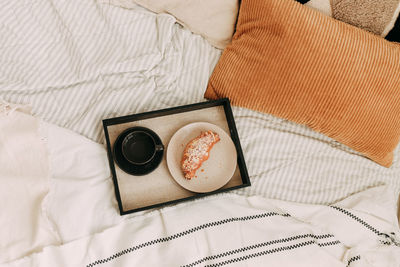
[205,240,339,267]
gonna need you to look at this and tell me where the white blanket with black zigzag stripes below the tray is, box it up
[0,187,400,267]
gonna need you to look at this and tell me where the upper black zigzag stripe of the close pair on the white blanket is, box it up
[182,234,340,267]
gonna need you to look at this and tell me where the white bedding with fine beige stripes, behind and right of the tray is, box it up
[0,0,400,207]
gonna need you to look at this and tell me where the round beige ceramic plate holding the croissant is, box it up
[167,122,237,193]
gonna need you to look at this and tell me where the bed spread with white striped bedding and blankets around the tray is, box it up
[0,0,400,266]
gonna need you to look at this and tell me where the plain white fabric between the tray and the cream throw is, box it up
[42,123,124,243]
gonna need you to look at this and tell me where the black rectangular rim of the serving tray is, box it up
[102,98,251,215]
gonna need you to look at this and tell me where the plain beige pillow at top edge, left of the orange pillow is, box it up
[105,0,238,49]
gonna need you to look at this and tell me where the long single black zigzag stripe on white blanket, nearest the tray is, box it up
[86,212,290,267]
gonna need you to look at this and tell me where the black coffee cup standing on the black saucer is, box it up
[122,127,164,165]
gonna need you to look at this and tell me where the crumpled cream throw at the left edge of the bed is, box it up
[0,101,59,262]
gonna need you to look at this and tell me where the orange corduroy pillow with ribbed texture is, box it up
[205,0,400,167]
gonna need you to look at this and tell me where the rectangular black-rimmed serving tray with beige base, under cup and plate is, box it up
[103,98,251,215]
